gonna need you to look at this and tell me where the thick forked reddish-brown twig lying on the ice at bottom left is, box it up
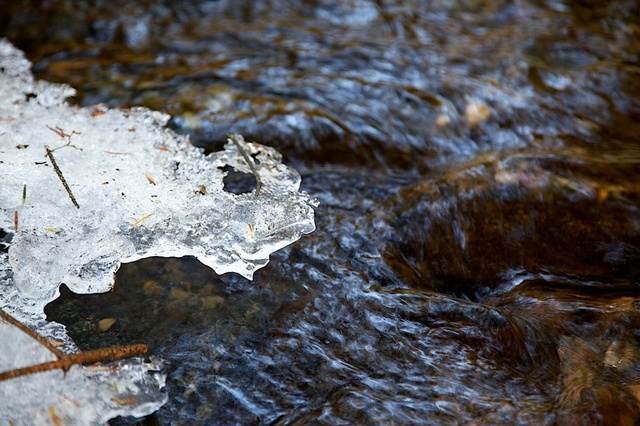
[0,310,148,381]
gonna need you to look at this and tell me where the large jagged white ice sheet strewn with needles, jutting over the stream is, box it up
[0,40,315,418]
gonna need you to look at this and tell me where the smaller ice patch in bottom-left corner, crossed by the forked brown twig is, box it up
[0,322,167,425]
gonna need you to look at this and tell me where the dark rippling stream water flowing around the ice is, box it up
[0,0,640,425]
